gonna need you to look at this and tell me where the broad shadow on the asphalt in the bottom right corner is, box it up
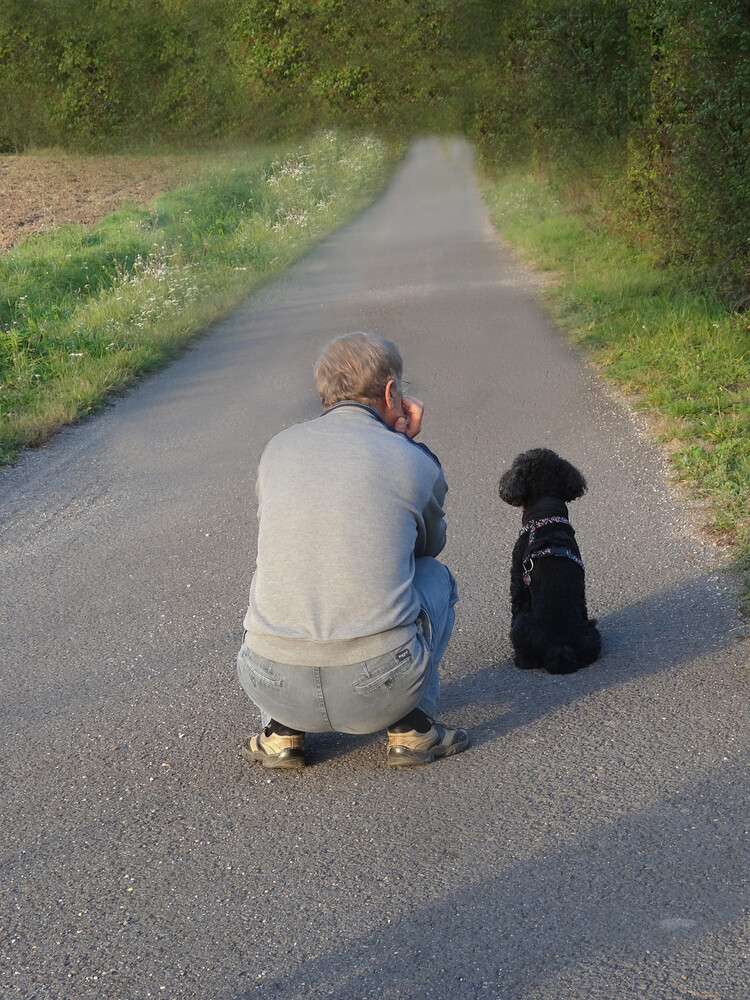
[232,760,750,1000]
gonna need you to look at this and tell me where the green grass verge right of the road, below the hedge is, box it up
[485,172,750,597]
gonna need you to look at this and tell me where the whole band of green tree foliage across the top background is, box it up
[0,0,750,304]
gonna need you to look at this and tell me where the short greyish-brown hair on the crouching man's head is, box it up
[314,331,404,409]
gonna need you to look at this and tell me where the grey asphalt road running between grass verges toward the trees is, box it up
[0,140,750,1000]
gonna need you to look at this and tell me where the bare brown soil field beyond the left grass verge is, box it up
[0,153,214,250]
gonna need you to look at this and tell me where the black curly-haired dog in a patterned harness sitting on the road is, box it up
[500,448,602,674]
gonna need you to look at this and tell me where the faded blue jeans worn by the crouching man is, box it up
[237,556,458,733]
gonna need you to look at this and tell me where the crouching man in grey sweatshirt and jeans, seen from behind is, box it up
[237,333,469,768]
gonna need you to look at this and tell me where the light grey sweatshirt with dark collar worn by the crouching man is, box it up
[244,402,448,666]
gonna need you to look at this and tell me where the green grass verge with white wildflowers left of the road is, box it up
[0,132,395,463]
